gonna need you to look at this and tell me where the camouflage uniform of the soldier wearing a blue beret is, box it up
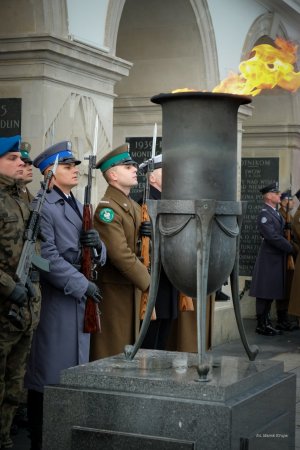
[0,175,40,448]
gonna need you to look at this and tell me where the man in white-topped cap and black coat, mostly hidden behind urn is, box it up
[139,155,179,350]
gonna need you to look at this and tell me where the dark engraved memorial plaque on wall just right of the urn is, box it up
[240,158,279,276]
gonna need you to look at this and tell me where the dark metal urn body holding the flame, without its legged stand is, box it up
[156,92,251,297]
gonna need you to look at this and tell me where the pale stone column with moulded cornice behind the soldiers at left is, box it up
[0,0,131,203]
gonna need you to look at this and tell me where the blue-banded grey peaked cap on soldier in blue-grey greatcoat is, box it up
[33,141,81,173]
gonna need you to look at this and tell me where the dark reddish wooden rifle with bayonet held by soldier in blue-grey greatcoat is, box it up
[81,115,101,333]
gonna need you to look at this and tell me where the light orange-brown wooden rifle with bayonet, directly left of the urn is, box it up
[140,123,157,320]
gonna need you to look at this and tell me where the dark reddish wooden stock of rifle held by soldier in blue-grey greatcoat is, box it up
[81,204,101,333]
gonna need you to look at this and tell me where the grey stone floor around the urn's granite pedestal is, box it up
[8,319,300,450]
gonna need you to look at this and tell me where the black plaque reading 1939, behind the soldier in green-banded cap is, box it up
[126,137,162,201]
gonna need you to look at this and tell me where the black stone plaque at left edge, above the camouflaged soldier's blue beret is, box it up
[0,98,22,137]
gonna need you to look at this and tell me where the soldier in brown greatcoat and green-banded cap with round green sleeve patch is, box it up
[91,144,150,360]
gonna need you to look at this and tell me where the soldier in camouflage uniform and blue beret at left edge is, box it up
[0,136,40,448]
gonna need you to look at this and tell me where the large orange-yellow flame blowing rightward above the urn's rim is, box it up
[213,37,300,97]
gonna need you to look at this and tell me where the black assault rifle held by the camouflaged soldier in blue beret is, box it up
[7,156,58,329]
